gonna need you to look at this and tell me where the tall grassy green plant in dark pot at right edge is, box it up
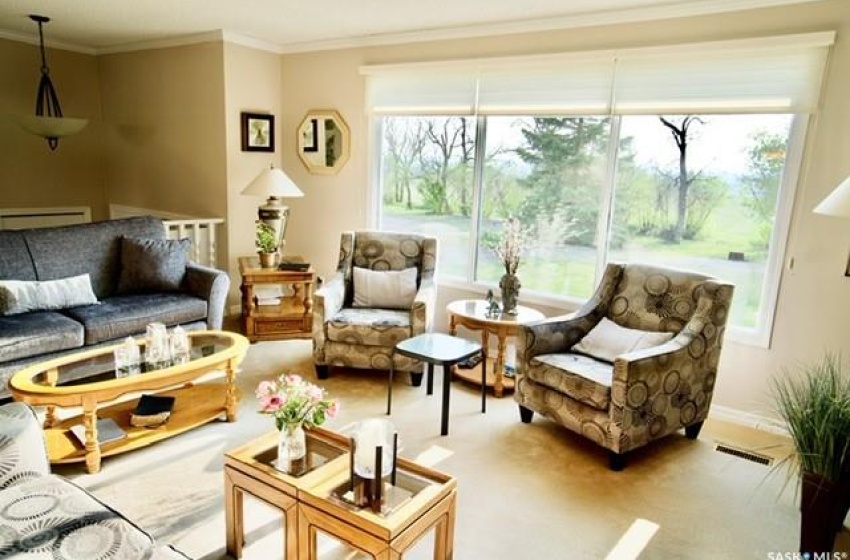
[774,353,850,554]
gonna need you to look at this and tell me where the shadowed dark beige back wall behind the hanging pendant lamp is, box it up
[0,39,107,219]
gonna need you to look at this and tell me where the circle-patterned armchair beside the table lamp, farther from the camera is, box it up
[313,231,437,385]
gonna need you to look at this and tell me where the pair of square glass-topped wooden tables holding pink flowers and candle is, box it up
[224,428,457,560]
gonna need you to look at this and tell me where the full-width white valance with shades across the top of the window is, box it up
[360,31,835,115]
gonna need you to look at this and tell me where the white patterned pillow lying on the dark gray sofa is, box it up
[0,273,97,315]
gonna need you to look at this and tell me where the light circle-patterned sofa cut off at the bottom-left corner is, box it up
[0,403,188,560]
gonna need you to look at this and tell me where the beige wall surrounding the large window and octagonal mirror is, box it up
[282,0,850,416]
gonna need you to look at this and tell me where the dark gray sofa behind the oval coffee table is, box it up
[0,216,230,398]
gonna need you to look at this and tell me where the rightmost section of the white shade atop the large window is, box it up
[613,32,834,114]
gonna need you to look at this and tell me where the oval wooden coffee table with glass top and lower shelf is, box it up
[9,331,249,473]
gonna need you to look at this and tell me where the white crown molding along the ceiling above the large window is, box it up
[280,0,820,54]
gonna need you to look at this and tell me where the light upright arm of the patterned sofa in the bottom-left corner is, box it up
[0,402,50,489]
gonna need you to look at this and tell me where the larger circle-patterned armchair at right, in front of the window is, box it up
[514,264,734,470]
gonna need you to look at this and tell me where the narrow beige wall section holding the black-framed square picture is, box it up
[224,43,284,304]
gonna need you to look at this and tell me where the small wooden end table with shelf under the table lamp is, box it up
[239,256,316,342]
